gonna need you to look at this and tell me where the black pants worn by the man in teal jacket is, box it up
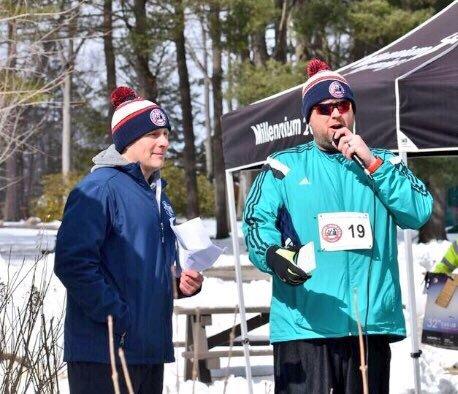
[274,335,391,394]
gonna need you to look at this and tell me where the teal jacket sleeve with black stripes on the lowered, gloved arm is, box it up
[242,160,285,274]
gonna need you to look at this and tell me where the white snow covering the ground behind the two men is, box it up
[0,220,458,394]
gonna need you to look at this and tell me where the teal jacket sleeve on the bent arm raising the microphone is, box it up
[372,152,433,229]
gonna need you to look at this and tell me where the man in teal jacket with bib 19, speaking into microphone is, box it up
[243,60,432,394]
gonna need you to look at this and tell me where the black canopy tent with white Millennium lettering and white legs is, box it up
[222,0,458,393]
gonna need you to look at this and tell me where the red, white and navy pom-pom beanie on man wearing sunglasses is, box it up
[302,59,356,123]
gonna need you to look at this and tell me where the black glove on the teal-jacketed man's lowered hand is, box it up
[266,246,311,286]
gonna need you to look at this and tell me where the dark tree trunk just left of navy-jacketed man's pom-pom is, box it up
[103,0,116,138]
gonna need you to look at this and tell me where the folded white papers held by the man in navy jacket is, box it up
[170,218,225,271]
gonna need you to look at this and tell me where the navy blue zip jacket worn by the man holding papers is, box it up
[54,163,176,365]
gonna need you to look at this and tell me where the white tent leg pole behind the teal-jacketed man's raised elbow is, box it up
[400,152,421,394]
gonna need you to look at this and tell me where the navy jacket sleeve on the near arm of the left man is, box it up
[54,184,130,334]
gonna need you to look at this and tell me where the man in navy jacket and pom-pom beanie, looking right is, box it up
[54,87,203,394]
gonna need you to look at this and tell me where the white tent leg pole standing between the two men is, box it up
[226,171,253,394]
